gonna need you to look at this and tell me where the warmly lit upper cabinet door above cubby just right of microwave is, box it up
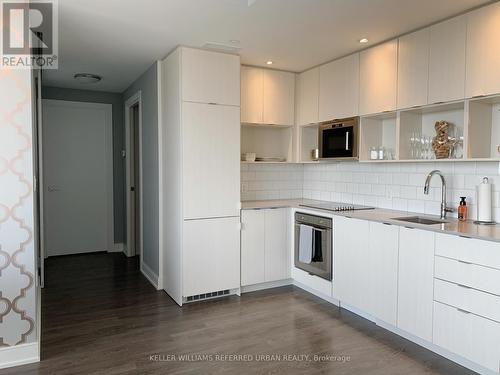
[359,40,398,115]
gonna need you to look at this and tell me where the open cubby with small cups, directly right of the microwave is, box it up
[359,112,398,162]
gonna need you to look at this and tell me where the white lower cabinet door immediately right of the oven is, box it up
[333,217,371,312]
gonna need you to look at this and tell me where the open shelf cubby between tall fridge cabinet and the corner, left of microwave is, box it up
[241,123,294,163]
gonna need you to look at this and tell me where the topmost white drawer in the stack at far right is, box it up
[436,234,500,269]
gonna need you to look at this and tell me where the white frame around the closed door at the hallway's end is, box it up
[40,98,115,257]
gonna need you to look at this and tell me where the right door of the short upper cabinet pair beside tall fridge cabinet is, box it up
[263,69,295,125]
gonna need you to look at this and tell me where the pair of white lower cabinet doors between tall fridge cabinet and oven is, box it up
[241,208,290,286]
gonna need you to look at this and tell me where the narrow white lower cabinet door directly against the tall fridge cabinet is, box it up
[241,210,265,286]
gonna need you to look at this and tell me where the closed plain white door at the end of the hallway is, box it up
[42,100,113,256]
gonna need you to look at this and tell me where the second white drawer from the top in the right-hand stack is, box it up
[434,256,500,296]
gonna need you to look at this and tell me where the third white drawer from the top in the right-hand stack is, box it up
[434,279,500,322]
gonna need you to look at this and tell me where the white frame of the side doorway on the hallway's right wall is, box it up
[125,90,144,262]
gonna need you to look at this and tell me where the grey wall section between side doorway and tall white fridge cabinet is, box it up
[123,63,159,275]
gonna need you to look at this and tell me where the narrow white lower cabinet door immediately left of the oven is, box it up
[264,208,290,281]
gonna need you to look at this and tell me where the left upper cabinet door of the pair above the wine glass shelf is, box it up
[398,28,430,108]
